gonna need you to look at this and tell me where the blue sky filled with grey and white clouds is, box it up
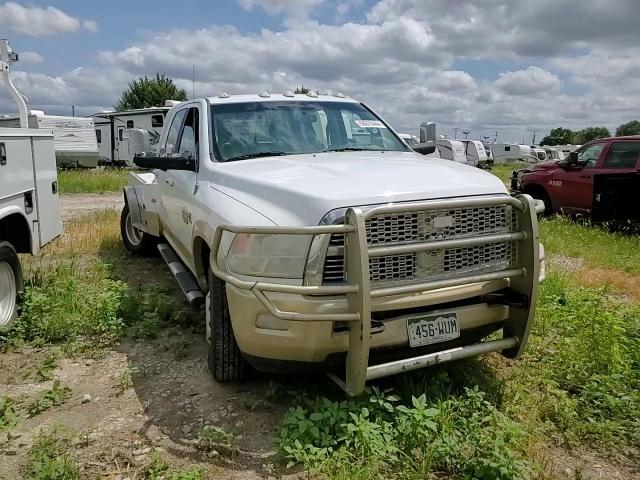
[0,0,640,143]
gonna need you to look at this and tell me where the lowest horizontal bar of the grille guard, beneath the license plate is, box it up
[327,337,518,391]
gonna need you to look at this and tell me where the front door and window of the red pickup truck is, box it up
[547,142,607,215]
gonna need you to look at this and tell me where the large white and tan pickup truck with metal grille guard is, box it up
[121,92,544,395]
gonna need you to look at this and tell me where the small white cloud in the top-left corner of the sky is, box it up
[0,2,98,37]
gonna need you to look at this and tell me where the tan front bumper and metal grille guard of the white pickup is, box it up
[211,195,540,395]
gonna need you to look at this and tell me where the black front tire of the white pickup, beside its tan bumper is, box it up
[205,269,247,382]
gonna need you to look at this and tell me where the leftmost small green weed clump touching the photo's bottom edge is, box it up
[24,430,80,480]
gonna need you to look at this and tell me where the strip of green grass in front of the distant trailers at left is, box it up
[58,168,131,193]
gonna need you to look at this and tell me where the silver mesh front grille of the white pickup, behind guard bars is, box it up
[323,205,518,286]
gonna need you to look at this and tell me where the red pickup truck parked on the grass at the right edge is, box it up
[511,136,640,223]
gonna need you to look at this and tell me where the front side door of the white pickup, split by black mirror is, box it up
[156,107,196,257]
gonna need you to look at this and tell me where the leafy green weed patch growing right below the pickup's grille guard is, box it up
[280,388,536,479]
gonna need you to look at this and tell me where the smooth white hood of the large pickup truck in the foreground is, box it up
[211,152,508,225]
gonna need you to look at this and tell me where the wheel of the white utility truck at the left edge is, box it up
[0,240,24,331]
